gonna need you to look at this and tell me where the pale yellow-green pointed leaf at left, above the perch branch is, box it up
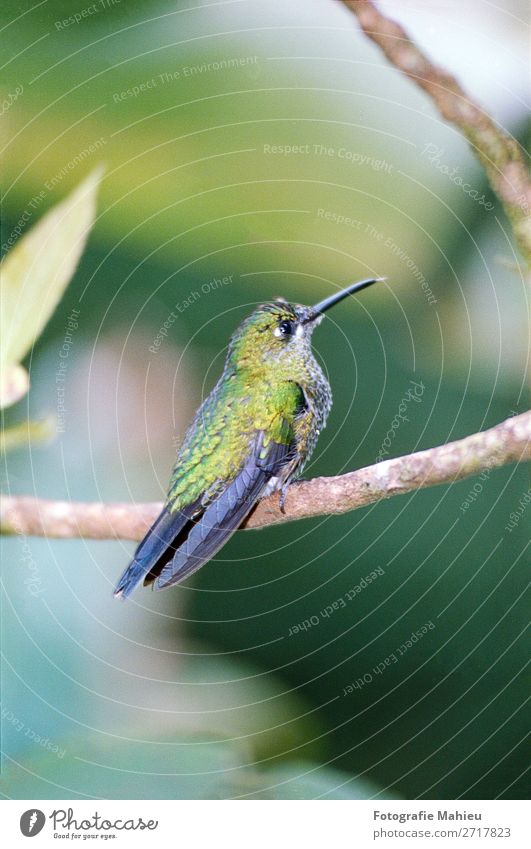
[0,167,102,406]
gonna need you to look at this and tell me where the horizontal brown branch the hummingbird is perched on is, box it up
[0,412,531,540]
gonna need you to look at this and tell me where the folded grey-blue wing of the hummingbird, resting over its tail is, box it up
[155,433,294,590]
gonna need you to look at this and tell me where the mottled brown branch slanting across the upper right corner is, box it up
[342,0,531,262]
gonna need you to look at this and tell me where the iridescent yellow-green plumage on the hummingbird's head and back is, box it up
[168,302,327,511]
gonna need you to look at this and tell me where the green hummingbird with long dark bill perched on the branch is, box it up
[114,278,382,598]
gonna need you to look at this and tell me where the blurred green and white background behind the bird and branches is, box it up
[1,0,529,799]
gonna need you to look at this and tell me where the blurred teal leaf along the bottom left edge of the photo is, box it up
[0,732,249,799]
